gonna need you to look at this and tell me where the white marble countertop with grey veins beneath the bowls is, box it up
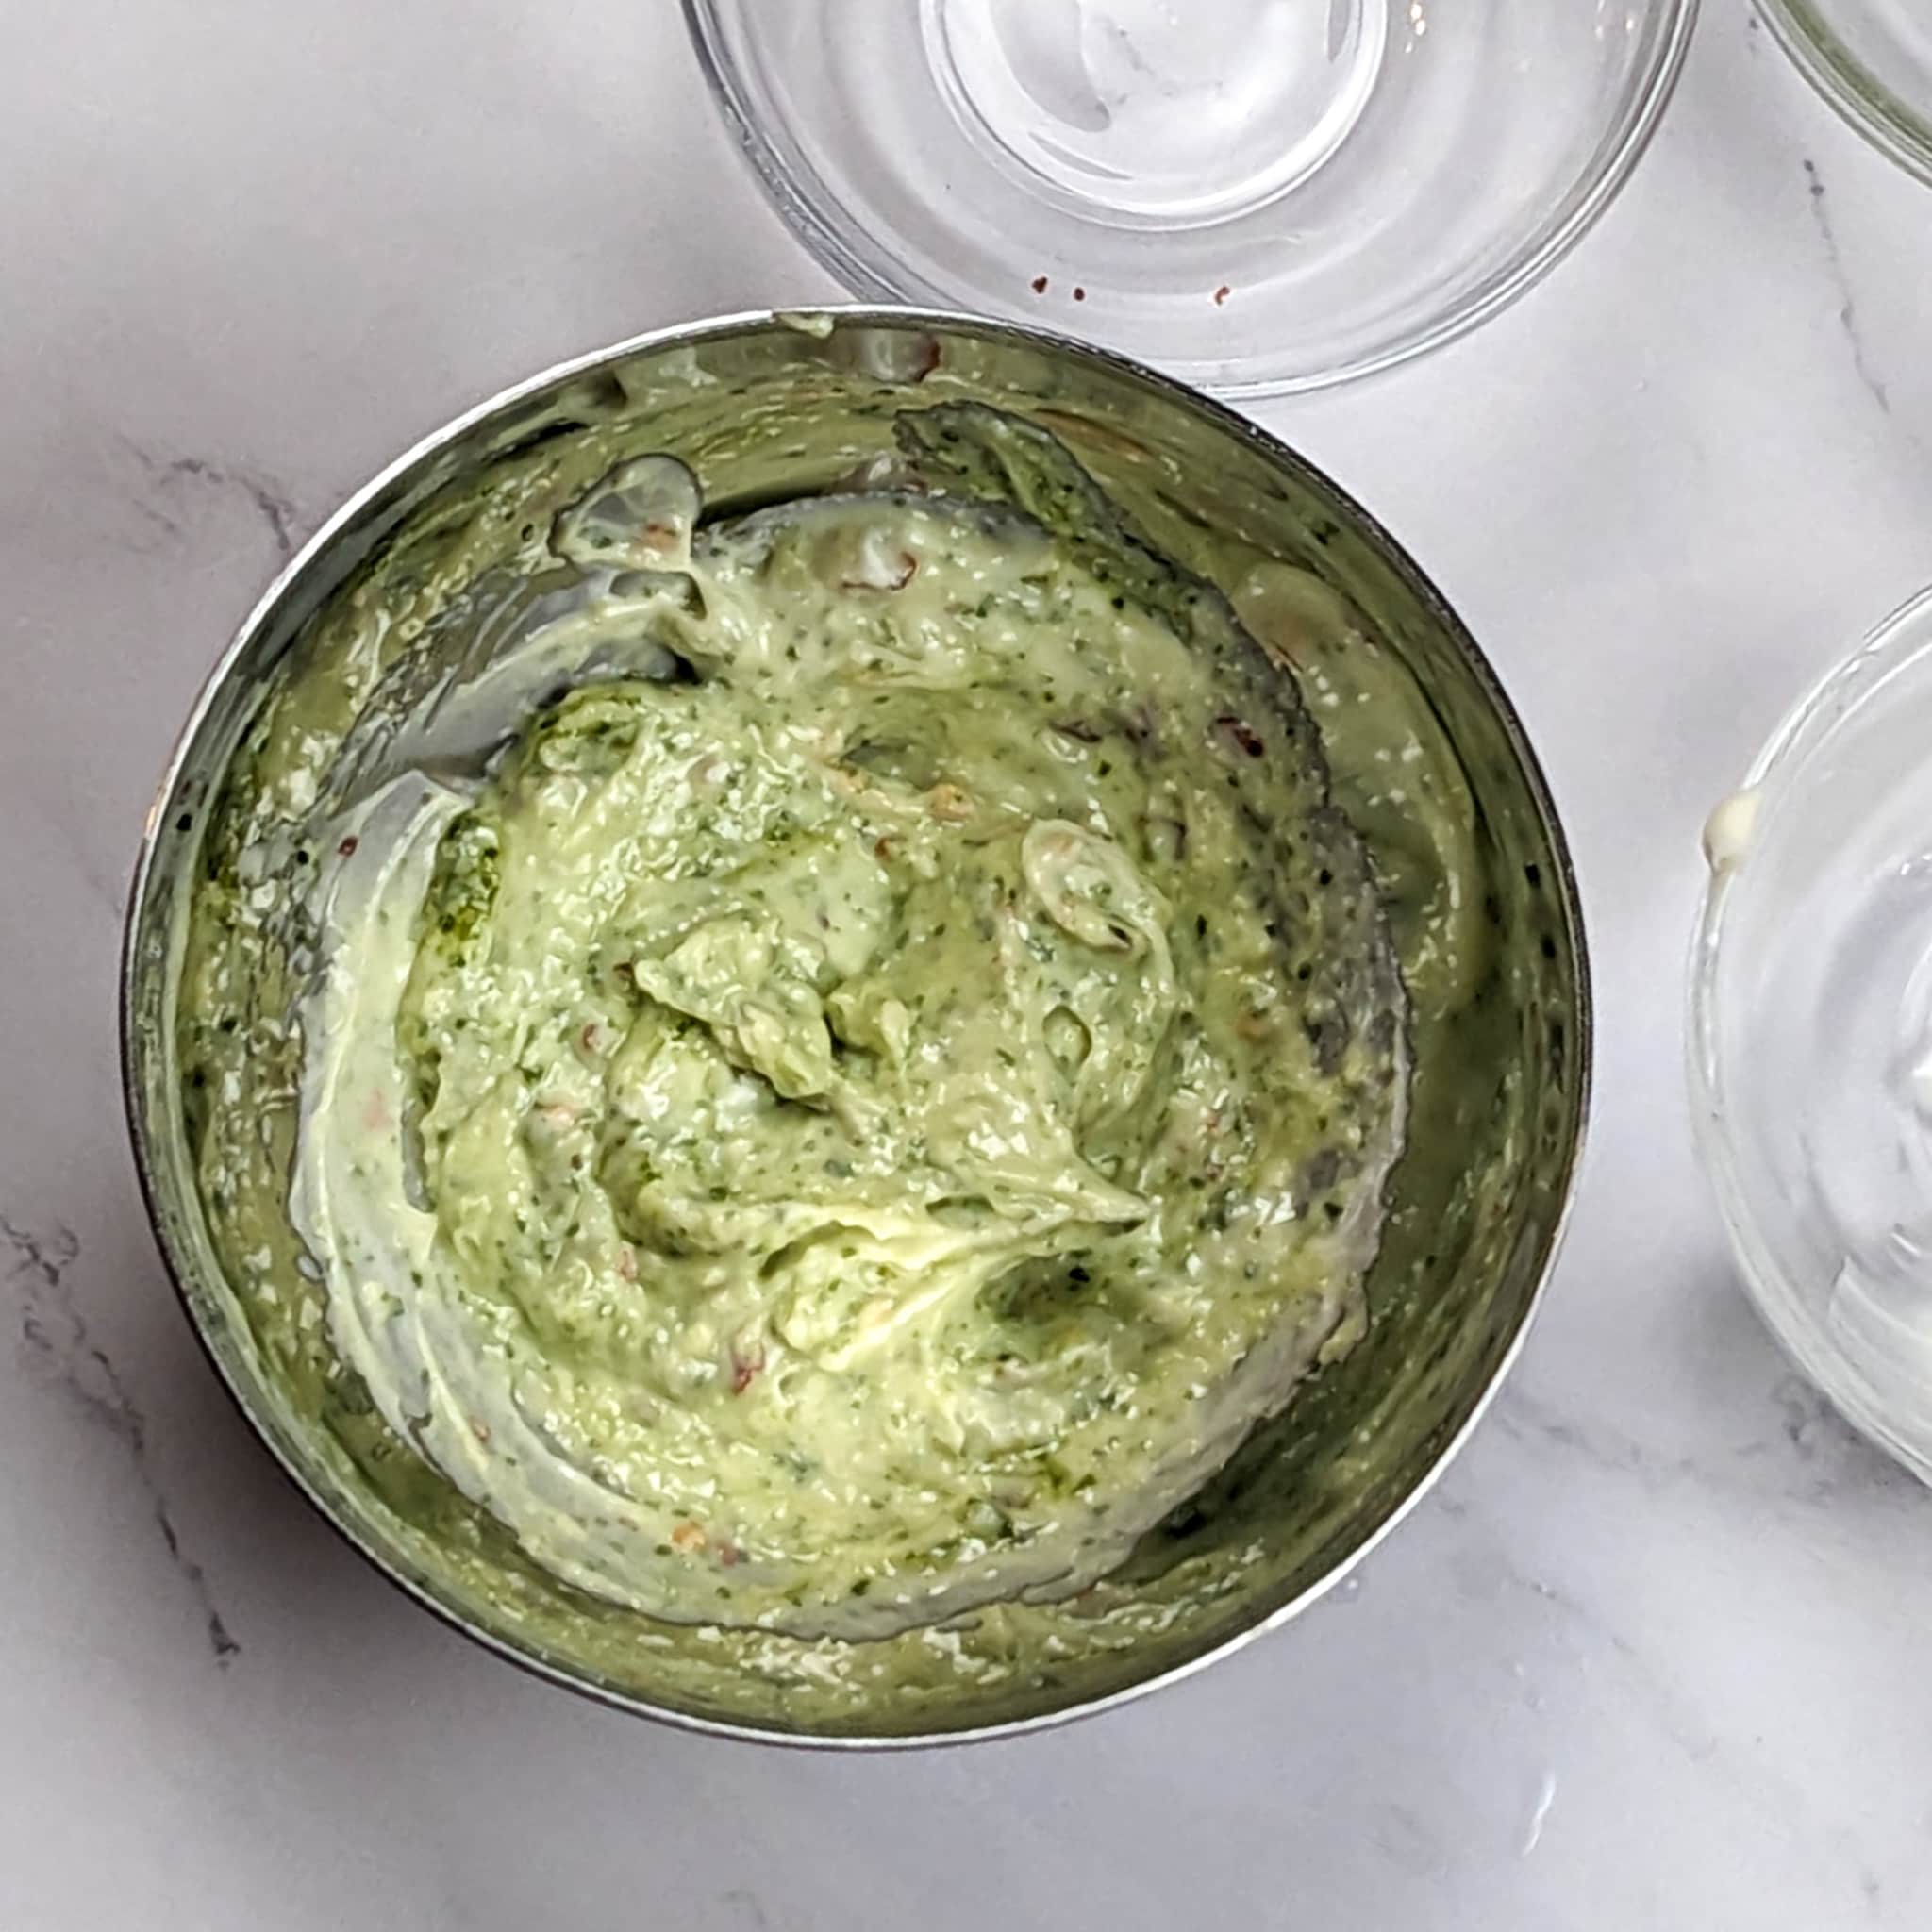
[0,0,1932,1932]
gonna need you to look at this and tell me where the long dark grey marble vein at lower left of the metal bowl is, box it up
[0,1215,242,1667]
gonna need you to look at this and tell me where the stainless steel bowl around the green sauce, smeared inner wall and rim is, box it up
[122,309,1591,1744]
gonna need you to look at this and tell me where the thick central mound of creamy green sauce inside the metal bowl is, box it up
[293,444,1407,1637]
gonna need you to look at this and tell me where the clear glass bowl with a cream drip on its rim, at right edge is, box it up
[1689,591,1932,1482]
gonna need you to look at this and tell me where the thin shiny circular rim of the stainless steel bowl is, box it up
[118,304,1596,1753]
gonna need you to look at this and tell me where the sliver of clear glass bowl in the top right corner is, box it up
[1758,0,1932,182]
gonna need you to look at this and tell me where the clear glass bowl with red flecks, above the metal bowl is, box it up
[684,0,1696,396]
